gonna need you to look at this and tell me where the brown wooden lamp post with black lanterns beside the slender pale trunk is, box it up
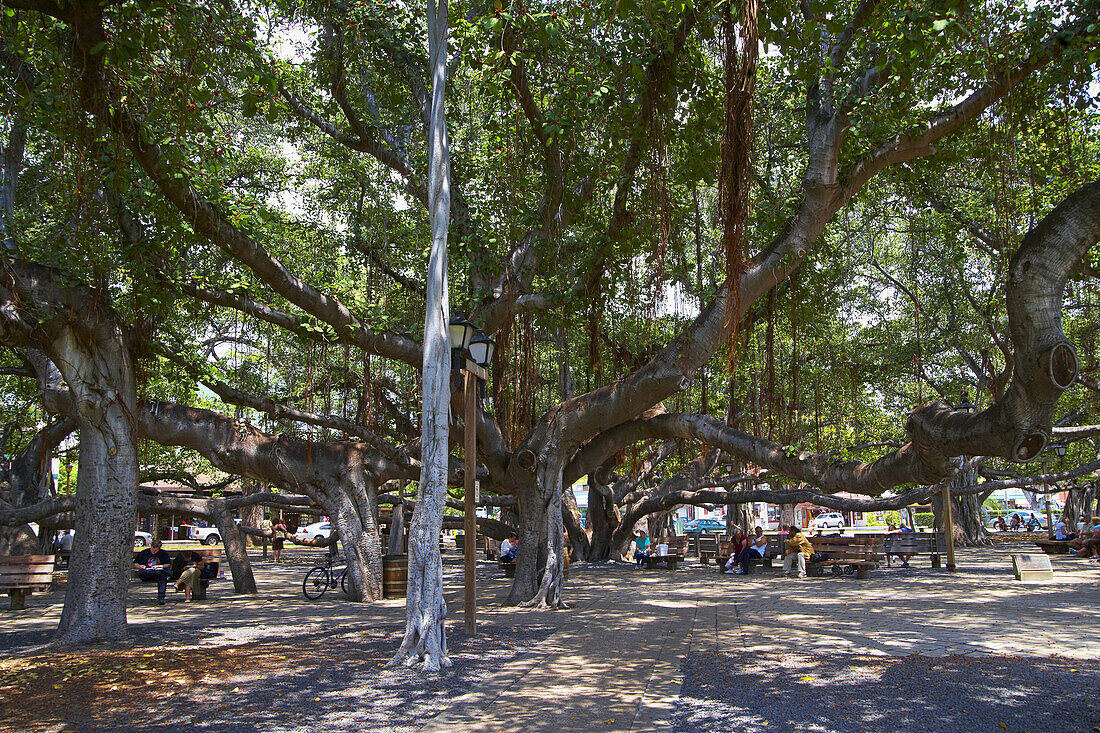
[449,313,496,634]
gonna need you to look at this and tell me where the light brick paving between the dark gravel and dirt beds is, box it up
[0,537,1100,732]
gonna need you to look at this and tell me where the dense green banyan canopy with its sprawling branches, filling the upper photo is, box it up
[0,0,1100,661]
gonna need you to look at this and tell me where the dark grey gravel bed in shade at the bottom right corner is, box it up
[672,653,1100,733]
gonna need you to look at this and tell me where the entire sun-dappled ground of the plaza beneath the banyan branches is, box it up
[0,544,1100,732]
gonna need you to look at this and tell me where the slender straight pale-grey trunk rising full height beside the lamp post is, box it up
[389,0,451,671]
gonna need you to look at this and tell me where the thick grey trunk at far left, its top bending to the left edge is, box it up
[0,260,138,644]
